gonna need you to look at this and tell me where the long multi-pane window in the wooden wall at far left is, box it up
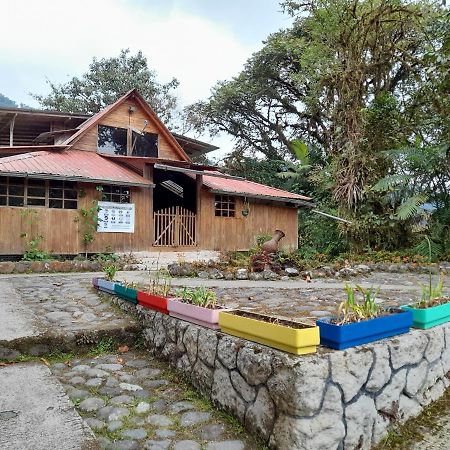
[0,177,78,209]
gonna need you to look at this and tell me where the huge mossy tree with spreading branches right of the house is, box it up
[195,0,438,212]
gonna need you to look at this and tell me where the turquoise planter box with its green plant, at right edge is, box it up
[402,236,450,330]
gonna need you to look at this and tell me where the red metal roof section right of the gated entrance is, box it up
[203,172,311,201]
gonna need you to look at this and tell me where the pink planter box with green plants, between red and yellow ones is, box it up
[167,287,227,329]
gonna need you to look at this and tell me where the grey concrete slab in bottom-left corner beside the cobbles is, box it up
[0,363,100,450]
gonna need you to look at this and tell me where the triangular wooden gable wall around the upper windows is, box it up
[73,100,182,161]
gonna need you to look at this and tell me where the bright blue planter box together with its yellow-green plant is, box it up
[317,285,412,350]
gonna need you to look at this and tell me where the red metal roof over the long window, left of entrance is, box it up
[0,150,151,186]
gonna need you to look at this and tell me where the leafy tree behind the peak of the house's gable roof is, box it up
[32,49,178,125]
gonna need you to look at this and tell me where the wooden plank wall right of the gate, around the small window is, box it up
[199,189,298,251]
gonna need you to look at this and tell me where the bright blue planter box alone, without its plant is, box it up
[317,310,413,350]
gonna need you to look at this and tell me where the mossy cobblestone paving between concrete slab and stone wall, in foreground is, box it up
[51,351,261,450]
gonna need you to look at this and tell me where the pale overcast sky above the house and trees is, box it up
[0,0,289,158]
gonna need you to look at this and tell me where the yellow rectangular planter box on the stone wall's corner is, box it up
[219,310,320,355]
